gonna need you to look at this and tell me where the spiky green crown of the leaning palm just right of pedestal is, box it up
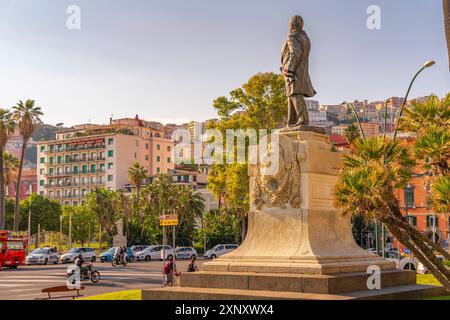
[335,137,415,219]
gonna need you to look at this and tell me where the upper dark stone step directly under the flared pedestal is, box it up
[180,270,416,294]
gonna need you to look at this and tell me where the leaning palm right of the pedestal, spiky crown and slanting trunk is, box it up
[335,137,450,291]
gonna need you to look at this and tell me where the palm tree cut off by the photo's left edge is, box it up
[0,109,14,230]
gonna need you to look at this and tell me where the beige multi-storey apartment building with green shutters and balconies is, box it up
[37,116,174,205]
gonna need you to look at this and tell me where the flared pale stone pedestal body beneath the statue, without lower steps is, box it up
[202,131,395,274]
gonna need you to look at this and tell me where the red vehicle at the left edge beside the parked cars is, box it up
[0,230,28,269]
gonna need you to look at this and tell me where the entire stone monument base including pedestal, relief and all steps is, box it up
[142,131,443,300]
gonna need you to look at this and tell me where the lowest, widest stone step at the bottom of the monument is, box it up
[142,285,445,300]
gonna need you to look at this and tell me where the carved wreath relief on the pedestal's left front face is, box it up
[252,136,302,210]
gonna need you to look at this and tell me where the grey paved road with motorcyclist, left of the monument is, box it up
[0,260,202,300]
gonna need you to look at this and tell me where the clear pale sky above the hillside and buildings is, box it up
[0,0,450,125]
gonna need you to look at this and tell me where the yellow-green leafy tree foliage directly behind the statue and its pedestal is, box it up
[208,73,287,212]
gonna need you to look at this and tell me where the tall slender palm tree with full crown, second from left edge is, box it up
[12,100,43,231]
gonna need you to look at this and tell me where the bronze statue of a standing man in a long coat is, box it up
[280,16,316,127]
